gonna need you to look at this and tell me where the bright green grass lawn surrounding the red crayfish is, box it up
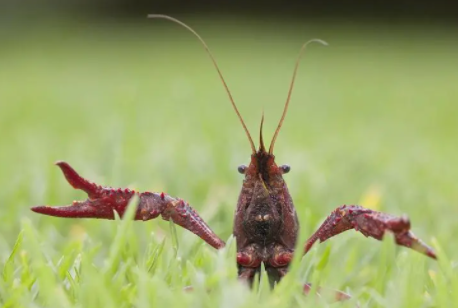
[0,18,458,308]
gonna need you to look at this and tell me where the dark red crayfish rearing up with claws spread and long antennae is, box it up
[32,15,436,298]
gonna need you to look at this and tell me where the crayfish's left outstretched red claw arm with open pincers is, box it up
[31,161,225,249]
